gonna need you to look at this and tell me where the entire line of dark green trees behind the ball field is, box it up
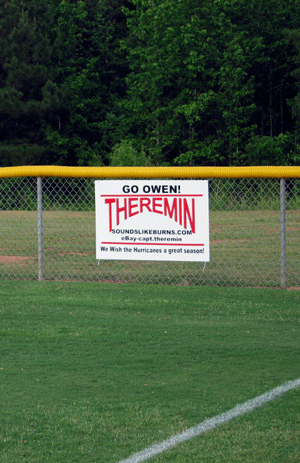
[0,0,300,166]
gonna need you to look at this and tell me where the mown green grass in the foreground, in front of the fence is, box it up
[0,281,300,463]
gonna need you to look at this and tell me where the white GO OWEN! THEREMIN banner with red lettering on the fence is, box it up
[95,180,209,262]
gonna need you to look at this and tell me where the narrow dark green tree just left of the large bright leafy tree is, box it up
[40,0,126,165]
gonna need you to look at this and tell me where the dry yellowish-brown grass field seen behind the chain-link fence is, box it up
[0,210,300,287]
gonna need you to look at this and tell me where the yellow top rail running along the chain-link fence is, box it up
[0,166,300,178]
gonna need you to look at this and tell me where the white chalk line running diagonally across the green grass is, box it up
[119,378,300,463]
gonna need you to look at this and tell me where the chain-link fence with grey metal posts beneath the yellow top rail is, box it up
[0,177,300,287]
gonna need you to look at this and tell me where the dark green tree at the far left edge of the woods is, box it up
[0,1,53,165]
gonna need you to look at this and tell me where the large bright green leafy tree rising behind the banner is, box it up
[122,0,260,164]
